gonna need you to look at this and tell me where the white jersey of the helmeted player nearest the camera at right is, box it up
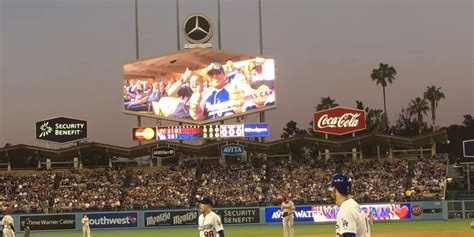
[336,198,370,237]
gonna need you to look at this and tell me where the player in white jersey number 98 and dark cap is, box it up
[198,197,225,237]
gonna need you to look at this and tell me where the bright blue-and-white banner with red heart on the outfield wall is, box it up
[265,203,411,223]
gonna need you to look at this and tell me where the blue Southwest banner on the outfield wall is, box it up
[87,212,138,229]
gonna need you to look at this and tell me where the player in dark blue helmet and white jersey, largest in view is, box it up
[331,174,370,237]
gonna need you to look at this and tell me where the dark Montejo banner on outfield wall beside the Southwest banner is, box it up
[145,210,199,227]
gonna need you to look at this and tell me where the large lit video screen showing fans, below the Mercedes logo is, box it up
[122,49,275,124]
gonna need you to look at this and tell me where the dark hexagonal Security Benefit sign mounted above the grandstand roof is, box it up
[36,117,87,143]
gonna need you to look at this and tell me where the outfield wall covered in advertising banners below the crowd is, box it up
[13,201,448,231]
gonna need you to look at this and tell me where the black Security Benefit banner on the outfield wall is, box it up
[214,208,260,225]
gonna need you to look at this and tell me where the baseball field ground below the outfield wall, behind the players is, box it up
[25,220,474,237]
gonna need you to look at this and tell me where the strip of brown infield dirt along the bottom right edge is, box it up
[262,230,474,237]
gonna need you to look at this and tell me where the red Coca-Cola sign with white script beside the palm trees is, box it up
[313,107,365,135]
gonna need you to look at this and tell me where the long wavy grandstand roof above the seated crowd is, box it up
[0,130,448,163]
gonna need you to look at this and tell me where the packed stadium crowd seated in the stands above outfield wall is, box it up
[0,158,446,212]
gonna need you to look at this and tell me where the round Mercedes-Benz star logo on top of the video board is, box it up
[184,14,212,44]
